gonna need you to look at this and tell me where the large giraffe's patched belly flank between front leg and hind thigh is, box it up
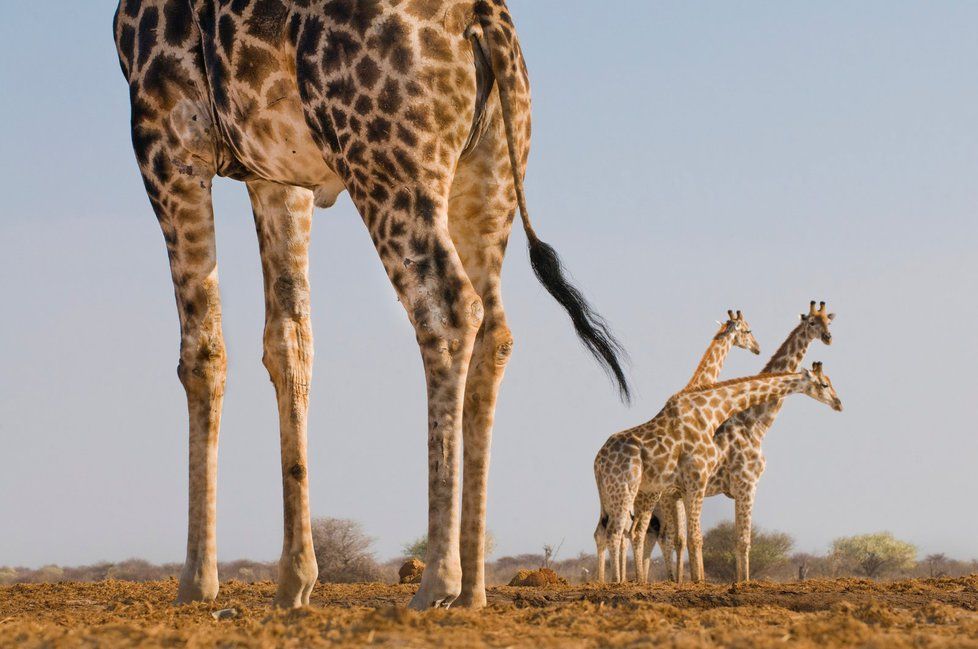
[197,0,340,192]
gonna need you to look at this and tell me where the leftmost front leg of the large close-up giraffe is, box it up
[124,88,227,603]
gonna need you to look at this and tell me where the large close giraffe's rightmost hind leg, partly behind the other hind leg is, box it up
[448,124,516,608]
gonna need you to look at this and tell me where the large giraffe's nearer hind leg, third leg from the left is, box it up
[328,177,484,610]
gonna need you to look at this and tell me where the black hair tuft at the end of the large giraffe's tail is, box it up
[527,233,631,403]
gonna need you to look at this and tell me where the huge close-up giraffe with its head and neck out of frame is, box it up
[114,0,628,609]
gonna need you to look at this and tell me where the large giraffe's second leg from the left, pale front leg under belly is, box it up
[248,181,319,608]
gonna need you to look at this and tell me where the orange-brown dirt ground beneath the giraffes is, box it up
[0,575,978,648]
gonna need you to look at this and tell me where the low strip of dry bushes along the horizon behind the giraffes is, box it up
[0,518,978,585]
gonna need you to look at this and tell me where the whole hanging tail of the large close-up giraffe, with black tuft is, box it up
[469,10,631,403]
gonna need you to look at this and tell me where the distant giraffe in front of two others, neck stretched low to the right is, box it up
[594,363,842,581]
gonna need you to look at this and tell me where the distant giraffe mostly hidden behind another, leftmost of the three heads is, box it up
[594,309,761,581]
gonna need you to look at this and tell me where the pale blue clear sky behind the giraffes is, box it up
[0,0,978,565]
